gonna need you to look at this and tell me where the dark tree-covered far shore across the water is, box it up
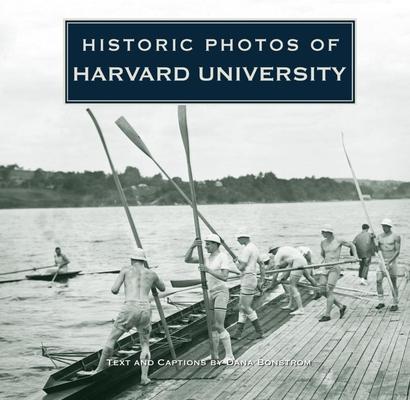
[0,164,410,207]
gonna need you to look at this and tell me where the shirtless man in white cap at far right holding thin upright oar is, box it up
[376,218,401,311]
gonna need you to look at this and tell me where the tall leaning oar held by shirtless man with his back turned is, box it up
[87,108,177,360]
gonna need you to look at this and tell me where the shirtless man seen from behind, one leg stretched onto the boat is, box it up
[79,249,165,385]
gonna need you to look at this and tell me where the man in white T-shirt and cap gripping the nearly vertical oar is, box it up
[185,234,235,364]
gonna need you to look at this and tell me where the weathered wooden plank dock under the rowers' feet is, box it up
[116,271,410,400]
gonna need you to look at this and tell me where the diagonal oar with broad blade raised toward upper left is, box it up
[115,117,237,260]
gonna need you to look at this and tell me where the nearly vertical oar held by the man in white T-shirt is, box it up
[178,106,217,360]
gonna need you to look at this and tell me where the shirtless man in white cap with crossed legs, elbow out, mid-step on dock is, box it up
[319,225,357,322]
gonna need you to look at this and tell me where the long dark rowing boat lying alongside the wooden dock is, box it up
[36,285,278,400]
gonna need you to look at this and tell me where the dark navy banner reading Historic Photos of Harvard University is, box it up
[65,21,355,103]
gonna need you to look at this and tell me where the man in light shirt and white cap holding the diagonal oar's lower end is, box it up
[232,233,265,340]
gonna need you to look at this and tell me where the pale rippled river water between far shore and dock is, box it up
[0,200,410,399]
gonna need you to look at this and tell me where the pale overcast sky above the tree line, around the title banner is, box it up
[0,0,410,181]
